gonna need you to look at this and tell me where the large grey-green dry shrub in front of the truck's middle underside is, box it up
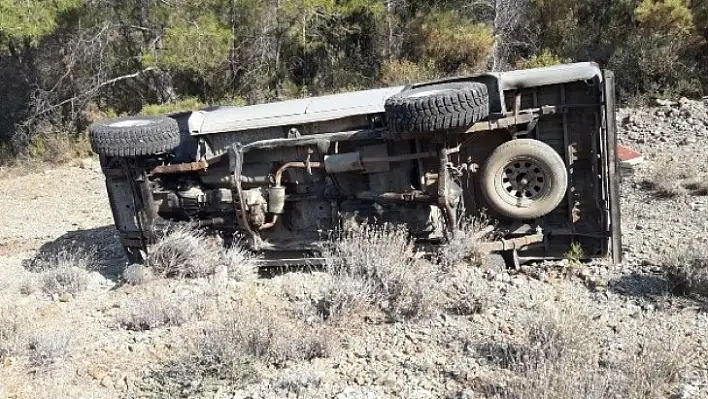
[321,225,439,320]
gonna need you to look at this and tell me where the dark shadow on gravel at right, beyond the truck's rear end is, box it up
[608,273,708,312]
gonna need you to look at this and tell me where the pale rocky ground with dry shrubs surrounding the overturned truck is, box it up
[0,100,708,399]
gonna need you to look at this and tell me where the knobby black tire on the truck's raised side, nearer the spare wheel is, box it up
[384,82,489,133]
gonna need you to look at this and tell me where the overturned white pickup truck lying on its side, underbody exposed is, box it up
[91,63,621,265]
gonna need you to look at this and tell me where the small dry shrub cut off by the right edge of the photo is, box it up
[663,243,708,297]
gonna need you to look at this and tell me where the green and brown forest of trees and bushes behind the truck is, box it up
[0,0,708,163]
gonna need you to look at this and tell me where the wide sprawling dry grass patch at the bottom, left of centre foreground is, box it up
[142,294,334,397]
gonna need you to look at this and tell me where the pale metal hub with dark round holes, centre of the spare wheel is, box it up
[501,160,548,201]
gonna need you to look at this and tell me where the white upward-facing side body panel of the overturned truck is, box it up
[188,62,602,135]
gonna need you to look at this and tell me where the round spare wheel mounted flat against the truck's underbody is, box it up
[480,139,568,220]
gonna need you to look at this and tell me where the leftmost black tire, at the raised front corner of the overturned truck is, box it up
[89,116,180,157]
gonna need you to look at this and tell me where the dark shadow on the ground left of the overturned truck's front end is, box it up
[22,225,126,280]
